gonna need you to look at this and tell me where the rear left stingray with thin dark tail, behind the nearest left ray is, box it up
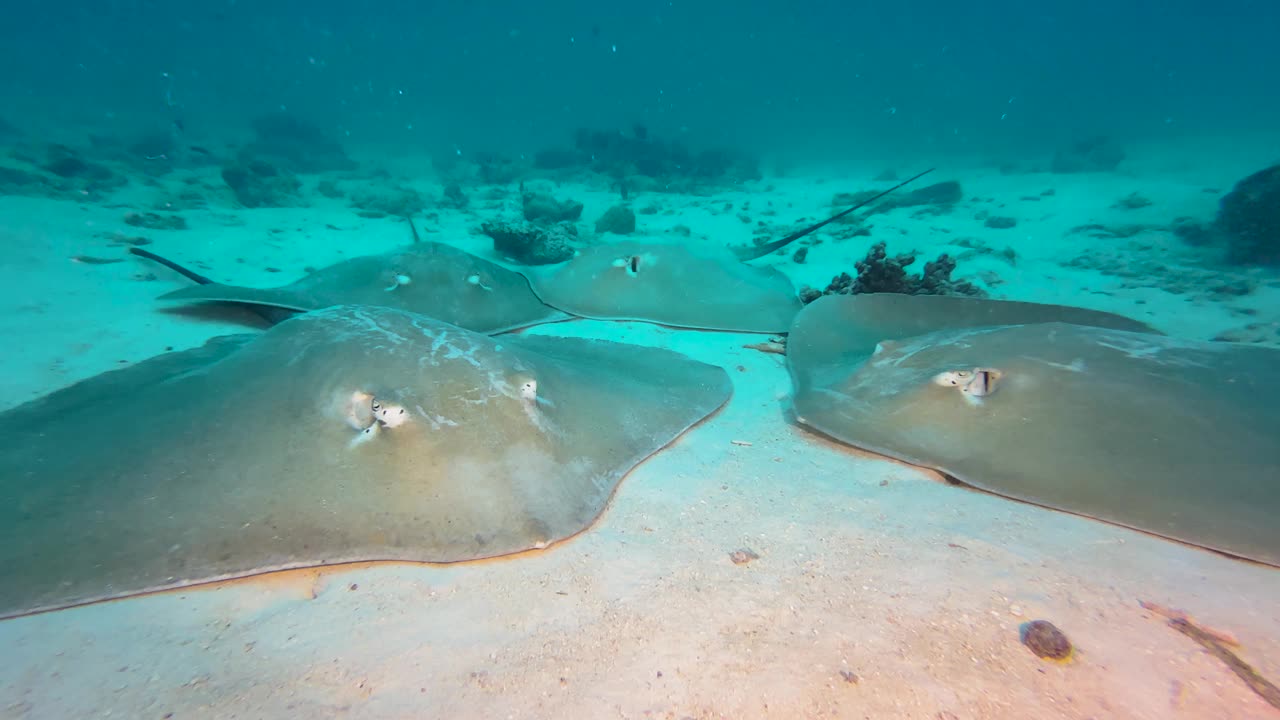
[132,242,567,333]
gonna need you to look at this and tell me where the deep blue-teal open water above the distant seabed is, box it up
[0,0,1280,163]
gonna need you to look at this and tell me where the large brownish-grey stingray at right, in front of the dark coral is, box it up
[788,295,1280,565]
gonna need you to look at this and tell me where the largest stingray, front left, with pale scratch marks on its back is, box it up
[0,306,731,618]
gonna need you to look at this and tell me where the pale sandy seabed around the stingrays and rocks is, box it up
[0,156,1280,720]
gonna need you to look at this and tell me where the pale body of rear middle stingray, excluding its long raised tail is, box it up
[529,241,801,333]
